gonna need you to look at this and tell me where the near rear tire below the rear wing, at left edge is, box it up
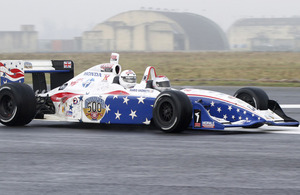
[0,83,36,126]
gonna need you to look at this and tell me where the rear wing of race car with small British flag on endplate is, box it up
[0,60,74,93]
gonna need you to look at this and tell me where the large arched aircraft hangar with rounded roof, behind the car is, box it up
[81,10,229,52]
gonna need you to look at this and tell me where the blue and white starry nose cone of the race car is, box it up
[183,89,267,129]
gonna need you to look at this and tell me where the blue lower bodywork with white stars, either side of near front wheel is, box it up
[91,95,299,130]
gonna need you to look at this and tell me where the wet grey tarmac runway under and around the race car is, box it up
[0,87,300,195]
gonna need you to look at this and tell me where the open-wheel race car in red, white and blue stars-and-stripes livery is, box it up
[0,53,299,132]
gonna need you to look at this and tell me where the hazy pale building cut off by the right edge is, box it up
[227,17,300,51]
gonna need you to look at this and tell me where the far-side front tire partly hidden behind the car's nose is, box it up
[234,87,269,110]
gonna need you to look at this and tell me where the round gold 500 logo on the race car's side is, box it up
[83,97,105,121]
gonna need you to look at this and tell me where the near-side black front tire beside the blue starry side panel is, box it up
[153,90,192,133]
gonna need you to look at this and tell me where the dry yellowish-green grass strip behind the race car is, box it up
[0,52,300,87]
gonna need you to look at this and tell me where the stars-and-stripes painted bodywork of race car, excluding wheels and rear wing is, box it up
[41,56,294,129]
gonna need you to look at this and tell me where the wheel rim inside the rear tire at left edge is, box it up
[0,95,16,120]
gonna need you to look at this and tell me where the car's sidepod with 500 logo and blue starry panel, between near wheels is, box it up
[52,94,155,125]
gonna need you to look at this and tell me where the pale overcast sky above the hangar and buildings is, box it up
[0,0,300,39]
